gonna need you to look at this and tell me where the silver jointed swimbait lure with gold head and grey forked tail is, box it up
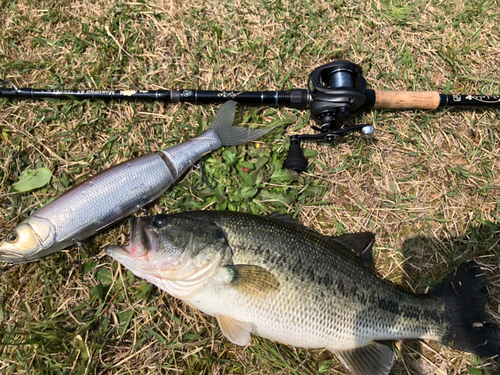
[0,101,271,263]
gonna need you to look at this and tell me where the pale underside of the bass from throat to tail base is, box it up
[185,278,441,350]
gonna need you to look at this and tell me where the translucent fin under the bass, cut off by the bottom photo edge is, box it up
[330,341,394,375]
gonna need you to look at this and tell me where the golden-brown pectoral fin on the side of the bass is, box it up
[226,264,280,294]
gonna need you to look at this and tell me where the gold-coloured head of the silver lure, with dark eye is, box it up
[0,216,55,263]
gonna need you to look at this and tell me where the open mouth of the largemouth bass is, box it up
[105,217,160,258]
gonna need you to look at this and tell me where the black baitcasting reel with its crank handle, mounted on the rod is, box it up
[284,60,374,172]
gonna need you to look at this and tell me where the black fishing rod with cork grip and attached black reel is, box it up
[0,60,500,172]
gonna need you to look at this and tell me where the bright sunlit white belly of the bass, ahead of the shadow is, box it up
[185,284,368,350]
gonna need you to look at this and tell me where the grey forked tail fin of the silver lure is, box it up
[210,100,274,146]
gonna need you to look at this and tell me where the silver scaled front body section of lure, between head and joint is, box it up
[33,154,173,253]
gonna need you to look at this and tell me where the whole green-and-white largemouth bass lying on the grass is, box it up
[106,211,500,375]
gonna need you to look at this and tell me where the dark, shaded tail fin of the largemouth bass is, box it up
[429,262,500,357]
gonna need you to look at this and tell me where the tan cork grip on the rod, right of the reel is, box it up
[373,90,439,109]
